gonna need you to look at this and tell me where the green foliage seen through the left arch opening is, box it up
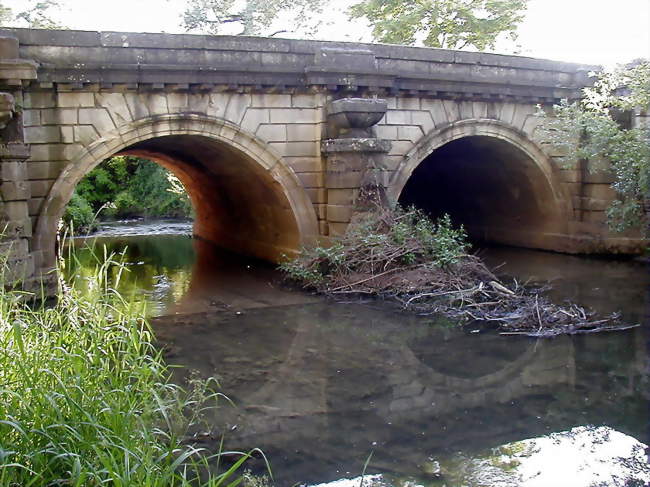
[64,156,192,229]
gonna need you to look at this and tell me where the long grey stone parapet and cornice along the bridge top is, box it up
[0,29,597,102]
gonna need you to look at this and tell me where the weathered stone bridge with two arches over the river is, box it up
[0,29,643,290]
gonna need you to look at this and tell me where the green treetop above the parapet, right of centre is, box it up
[349,0,528,50]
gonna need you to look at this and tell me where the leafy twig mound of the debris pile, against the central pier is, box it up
[280,207,469,288]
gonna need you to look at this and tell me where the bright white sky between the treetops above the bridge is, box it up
[2,0,650,67]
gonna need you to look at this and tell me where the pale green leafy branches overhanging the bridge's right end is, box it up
[541,61,650,231]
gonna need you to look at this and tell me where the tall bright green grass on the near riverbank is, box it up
[0,250,248,487]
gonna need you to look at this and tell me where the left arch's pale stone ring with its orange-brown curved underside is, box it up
[34,114,318,270]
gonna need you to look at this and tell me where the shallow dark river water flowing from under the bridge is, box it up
[69,222,650,487]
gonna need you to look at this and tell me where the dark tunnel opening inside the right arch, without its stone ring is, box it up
[390,129,565,250]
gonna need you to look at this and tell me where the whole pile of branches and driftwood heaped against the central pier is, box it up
[281,208,626,336]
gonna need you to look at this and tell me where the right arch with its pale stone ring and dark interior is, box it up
[388,119,572,251]
